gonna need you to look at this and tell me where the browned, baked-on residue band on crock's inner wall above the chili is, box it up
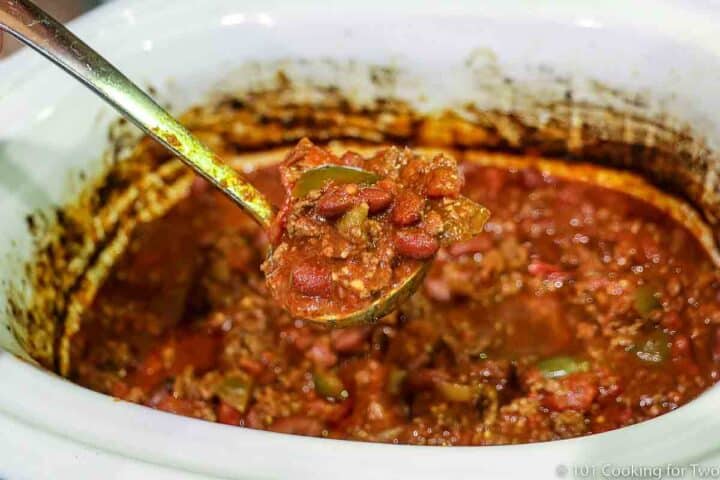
[9,68,720,374]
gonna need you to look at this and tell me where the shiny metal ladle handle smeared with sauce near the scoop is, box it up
[0,0,273,228]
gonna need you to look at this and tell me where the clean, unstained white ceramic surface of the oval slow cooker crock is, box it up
[0,0,720,479]
